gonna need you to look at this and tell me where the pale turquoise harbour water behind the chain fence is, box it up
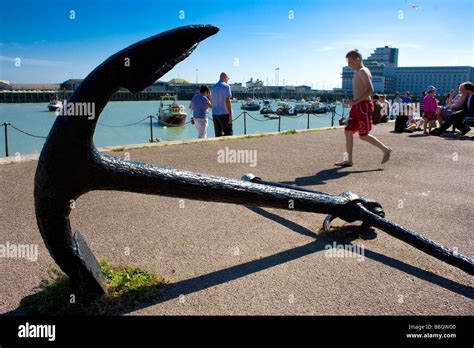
[0,101,348,157]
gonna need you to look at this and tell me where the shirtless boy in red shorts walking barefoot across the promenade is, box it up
[334,50,392,167]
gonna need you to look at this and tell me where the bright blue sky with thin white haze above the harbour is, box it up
[0,0,474,89]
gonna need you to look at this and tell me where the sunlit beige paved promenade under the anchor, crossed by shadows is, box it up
[0,124,474,315]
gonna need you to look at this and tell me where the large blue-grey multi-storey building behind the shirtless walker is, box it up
[342,46,474,94]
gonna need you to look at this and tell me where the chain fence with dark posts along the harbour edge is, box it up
[0,106,345,157]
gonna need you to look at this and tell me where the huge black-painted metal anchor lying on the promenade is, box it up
[34,25,474,293]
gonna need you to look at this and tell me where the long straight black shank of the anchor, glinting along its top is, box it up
[92,153,355,215]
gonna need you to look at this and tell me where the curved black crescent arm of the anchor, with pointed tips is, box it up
[34,25,219,293]
